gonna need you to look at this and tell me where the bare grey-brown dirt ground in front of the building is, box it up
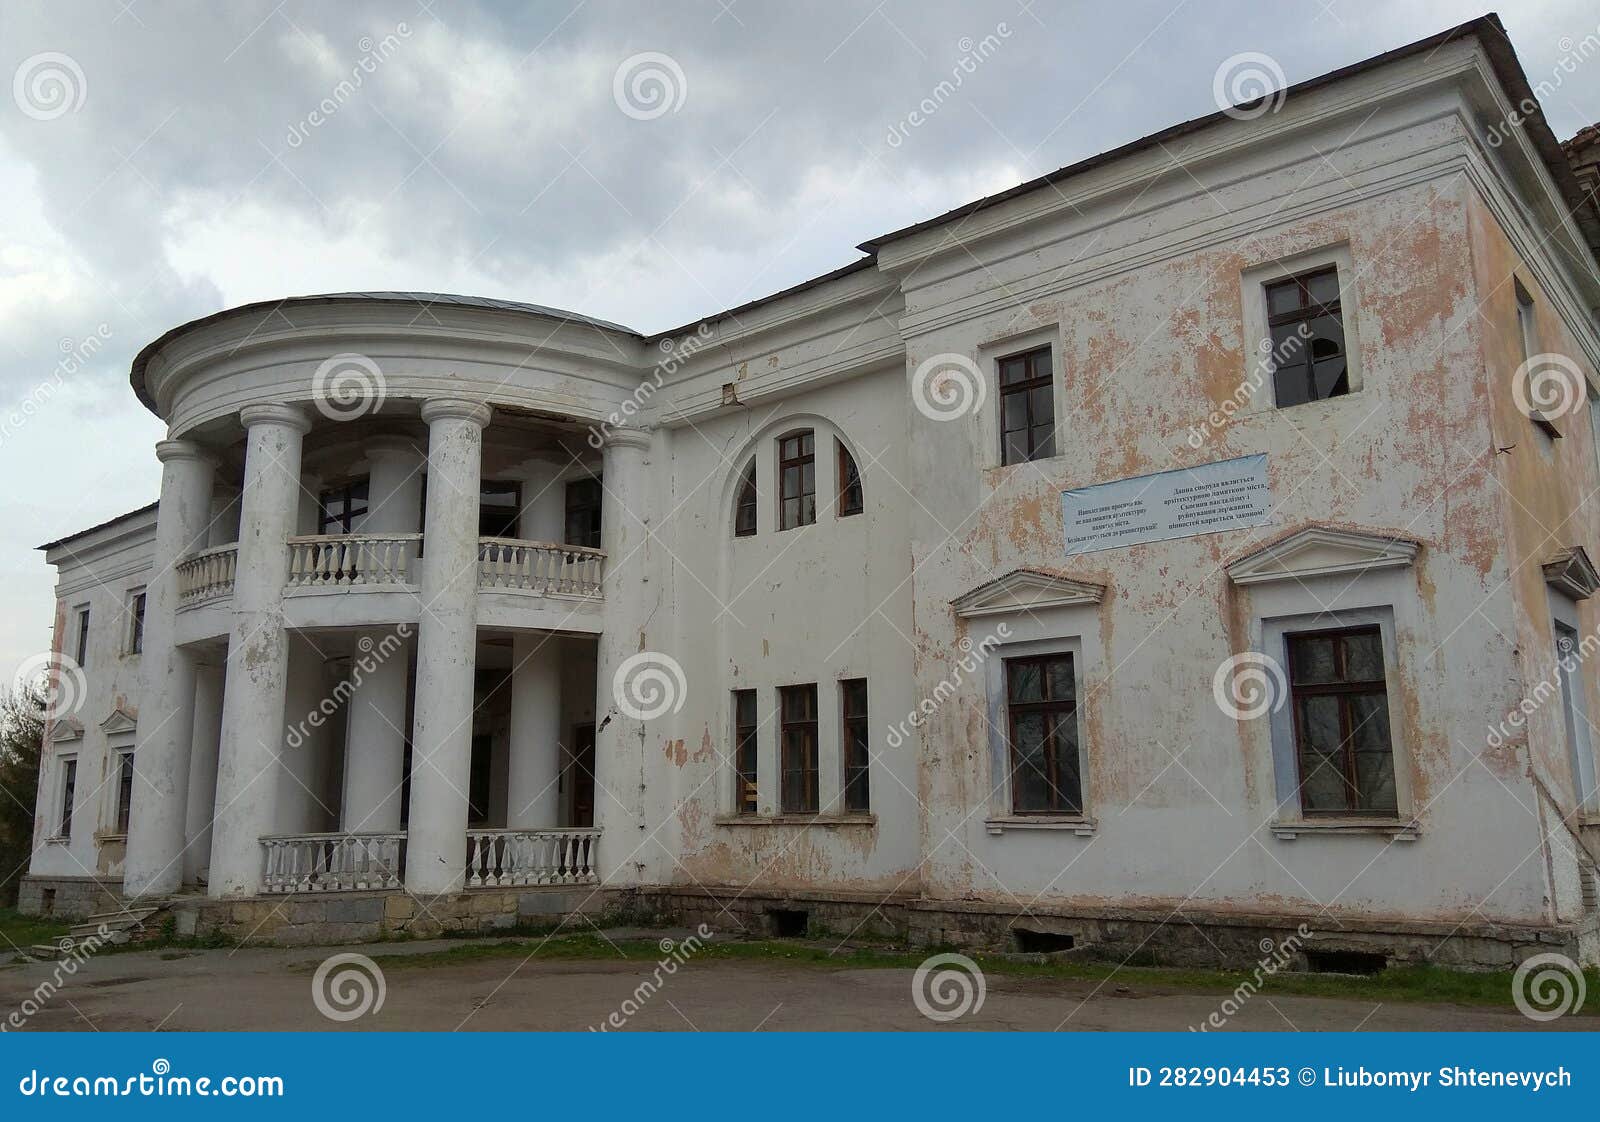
[0,943,1594,1032]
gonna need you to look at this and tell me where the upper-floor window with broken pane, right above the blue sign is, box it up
[1264,266,1350,408]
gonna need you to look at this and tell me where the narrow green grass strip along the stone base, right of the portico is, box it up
[373,933,1600,1016]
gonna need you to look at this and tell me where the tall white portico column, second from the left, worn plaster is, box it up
[210,405,310,896]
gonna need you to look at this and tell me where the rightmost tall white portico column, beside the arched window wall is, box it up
[595,429,656,884]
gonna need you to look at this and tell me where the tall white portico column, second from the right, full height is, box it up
[405,399,490,895]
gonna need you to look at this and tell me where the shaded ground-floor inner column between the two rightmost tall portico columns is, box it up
[506,632,562,829]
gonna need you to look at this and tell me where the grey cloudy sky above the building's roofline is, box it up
[0,0,1600,680]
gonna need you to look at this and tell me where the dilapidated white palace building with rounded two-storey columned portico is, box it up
[22,18,1600,967]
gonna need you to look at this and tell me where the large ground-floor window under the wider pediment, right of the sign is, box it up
[1285,627,1398,818]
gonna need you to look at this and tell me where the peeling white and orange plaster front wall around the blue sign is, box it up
[906,109,1589,922]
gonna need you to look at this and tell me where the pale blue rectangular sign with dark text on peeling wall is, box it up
[1061,453,1272,555]
